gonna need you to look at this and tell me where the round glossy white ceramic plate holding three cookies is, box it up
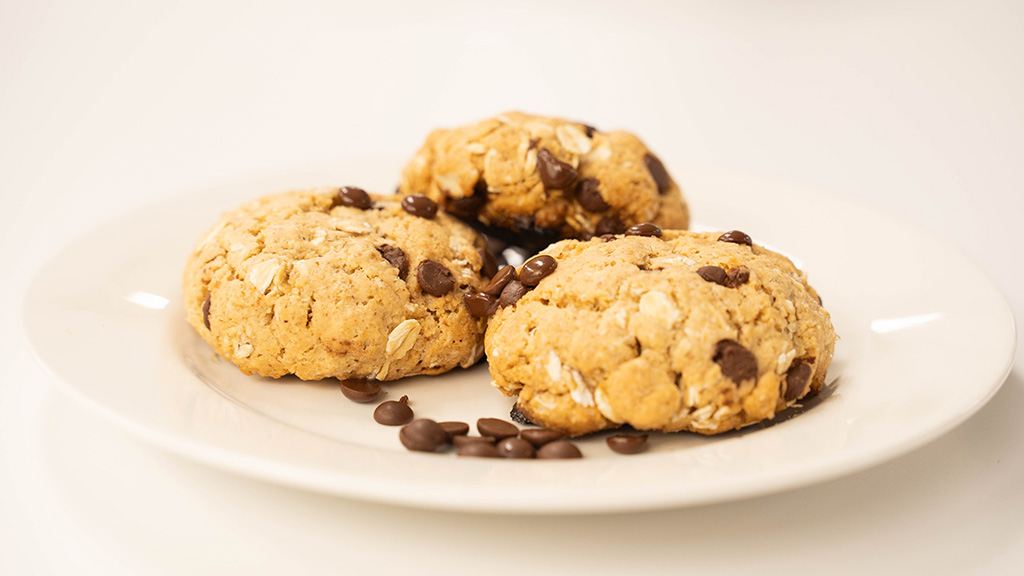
[25,159,1015,513]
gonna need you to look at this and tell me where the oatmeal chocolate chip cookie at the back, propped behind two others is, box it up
[398,112,689,249]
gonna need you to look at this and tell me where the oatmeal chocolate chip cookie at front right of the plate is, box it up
[484,227,836,436]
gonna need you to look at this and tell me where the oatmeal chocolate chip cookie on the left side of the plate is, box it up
[183,188,485,380]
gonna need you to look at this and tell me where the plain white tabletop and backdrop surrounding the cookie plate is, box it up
[0,0,1024,575]
